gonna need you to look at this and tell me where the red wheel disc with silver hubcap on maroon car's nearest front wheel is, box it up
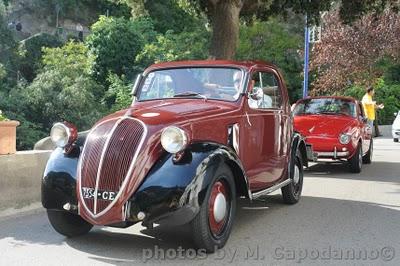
[208,181,230,236]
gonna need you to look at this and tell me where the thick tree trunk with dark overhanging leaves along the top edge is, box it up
[122,0,400,59]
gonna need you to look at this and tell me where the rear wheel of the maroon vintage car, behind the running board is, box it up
[281,151,303,204]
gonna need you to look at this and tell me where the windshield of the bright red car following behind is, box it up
[293,98,357,117]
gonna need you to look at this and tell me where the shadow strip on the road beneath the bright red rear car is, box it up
[304,161,400,184]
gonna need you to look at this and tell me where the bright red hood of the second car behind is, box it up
[294,115,355,137]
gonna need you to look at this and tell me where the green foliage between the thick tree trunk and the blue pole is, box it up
[236,19,303,100]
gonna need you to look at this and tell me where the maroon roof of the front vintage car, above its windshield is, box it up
[145,60,277,73]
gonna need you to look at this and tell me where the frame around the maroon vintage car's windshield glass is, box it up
[135,65,248,103]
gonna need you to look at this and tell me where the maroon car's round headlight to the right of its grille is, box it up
[161,126,188,153]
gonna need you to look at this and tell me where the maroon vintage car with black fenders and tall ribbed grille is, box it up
[42,61,307,252]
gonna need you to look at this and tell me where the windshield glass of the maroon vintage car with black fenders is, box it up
[138,67,244,101]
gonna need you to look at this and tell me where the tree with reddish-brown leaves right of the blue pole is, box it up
[310,10,400,94]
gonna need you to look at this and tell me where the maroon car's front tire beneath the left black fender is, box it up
[47,210,93,237]
